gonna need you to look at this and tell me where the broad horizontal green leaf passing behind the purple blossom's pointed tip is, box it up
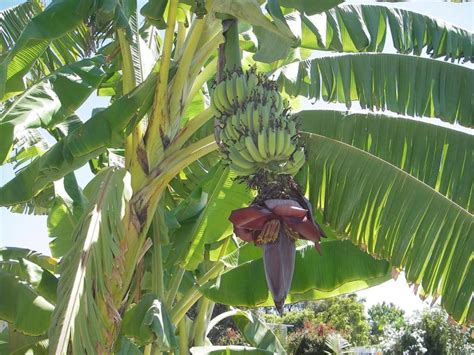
[200,240,391,307]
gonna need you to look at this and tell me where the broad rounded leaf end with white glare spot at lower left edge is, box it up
[0,270,54,336]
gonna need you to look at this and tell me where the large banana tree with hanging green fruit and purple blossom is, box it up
[0,0,474,354]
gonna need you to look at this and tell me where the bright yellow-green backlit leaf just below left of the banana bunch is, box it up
[178,164,252,270]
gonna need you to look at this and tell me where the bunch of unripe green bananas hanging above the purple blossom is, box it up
[211,70,305,176]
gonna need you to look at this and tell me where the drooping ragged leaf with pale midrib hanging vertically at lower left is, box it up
[49,168,132,354]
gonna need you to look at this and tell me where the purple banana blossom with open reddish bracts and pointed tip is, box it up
[229,199,325,313]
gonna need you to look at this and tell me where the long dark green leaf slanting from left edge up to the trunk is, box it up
[0,77,155,206]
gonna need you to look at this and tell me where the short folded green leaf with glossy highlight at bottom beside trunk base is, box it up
[122,293,177,351]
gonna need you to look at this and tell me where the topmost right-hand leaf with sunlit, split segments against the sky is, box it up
[301,1,474,61]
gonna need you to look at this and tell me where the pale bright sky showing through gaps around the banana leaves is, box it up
[0,0,474,314]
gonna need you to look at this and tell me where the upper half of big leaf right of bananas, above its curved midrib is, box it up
[297,110,474,212]
